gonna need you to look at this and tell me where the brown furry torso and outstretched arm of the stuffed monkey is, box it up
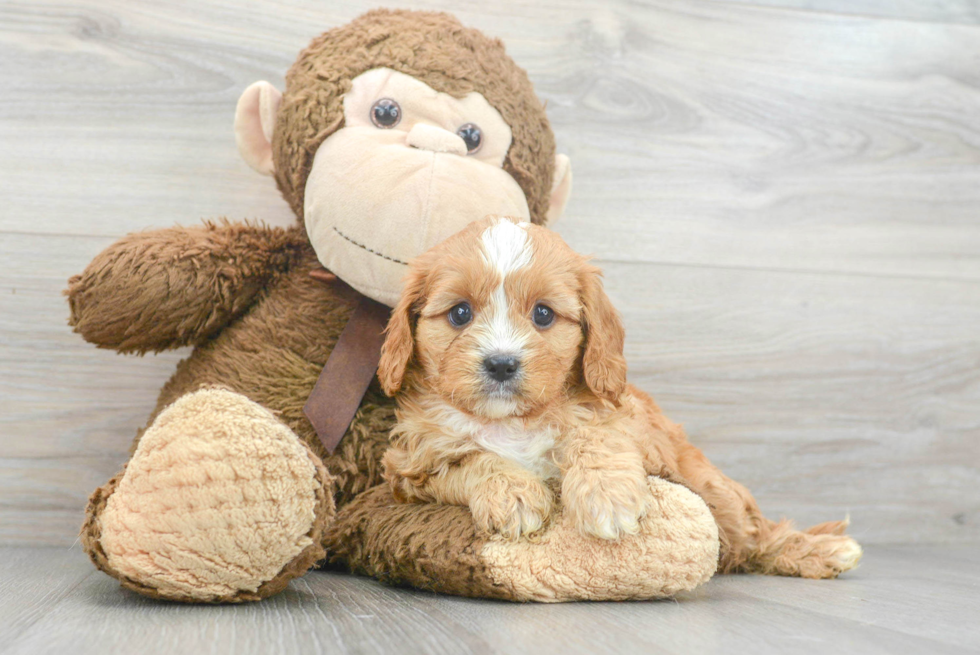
[68,224,394,504]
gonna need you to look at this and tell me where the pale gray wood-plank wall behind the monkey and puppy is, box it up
[0,0,980,545]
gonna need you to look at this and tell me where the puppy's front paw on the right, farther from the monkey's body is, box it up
[562,469,651,539]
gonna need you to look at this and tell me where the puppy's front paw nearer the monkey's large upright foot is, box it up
[470,478,554,539]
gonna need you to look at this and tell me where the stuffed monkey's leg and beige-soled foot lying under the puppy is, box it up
[326,477,719,602]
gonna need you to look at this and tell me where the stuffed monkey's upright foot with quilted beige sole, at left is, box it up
[82,389,334,602]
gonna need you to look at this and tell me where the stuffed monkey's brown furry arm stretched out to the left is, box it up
[65,221,306,353]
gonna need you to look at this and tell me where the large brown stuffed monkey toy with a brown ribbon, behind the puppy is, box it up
[67,10,718,602]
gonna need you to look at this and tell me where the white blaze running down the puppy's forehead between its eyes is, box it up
[479,219,532,358]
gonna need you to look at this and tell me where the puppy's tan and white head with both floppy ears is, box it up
[379,218,625,418]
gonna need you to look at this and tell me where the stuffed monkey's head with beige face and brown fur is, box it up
[235,10,571,305]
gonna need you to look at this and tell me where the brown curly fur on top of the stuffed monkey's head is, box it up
[272,9,555,223]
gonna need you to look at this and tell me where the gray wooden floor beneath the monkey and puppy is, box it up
[0,546,980,655]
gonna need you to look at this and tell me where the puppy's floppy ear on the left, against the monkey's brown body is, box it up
[378,261,427,396]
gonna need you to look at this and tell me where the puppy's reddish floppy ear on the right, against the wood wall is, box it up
[580,264,626,400]
